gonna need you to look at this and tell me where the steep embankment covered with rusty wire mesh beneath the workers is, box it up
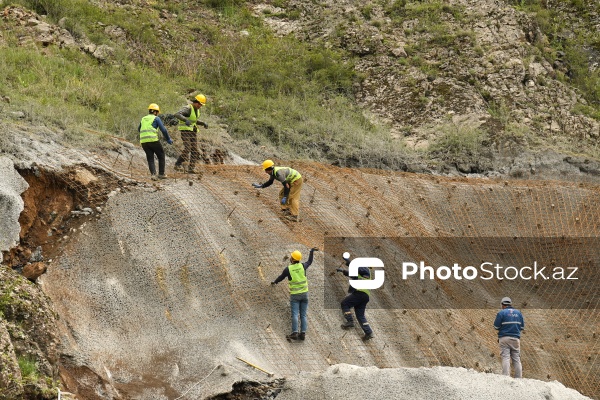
[2,135,588,399]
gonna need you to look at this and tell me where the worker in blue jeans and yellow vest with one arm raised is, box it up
[271,247,319,340]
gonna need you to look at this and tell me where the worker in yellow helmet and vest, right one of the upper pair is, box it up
[174,94,208,174]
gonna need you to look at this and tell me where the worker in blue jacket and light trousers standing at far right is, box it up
[494,297,525,378]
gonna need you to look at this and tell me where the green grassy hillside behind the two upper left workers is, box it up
[0,0,412,167]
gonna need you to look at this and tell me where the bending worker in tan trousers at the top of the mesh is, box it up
[252,160,303,222]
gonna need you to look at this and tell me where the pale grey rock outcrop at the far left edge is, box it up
[0,157,28,262]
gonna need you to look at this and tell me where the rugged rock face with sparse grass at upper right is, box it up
[255,0,600,173]
